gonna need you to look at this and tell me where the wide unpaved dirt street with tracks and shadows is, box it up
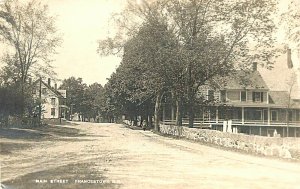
[0,123,300,189]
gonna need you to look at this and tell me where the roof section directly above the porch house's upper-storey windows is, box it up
[218,70,269,90]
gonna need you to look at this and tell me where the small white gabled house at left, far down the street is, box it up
[32,79,68,119]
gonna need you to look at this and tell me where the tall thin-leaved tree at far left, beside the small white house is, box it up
[0,0,60,113]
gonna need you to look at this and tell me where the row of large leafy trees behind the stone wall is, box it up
[98,0,276,130]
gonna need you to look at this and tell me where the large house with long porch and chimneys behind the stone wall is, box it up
[164,48,300,137]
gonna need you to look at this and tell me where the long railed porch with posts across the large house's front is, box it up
[162,106,300,137]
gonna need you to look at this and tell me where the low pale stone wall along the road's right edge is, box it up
[160,125,300,160]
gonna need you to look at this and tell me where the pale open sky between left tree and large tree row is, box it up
[45,0,125,85]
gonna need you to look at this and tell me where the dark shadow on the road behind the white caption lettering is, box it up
[3,163,121,189]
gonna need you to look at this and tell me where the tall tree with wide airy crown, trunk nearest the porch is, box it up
[166,0,276,127]
